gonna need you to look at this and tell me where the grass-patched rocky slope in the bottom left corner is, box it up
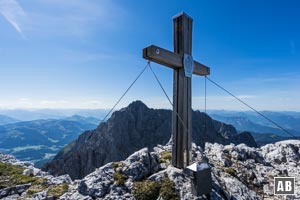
[0,153,72,200]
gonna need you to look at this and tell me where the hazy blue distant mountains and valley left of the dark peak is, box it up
[0,115,100,166]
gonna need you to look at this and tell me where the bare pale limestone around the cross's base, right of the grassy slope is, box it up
[59,140,300,200]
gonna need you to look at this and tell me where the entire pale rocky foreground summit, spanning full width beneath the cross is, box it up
[0,140,300,200]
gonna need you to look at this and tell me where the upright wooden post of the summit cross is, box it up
[172,13,193,169]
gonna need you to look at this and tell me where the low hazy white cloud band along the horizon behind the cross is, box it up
[0,92,300,111]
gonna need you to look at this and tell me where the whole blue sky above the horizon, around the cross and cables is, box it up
[0,0,300,111]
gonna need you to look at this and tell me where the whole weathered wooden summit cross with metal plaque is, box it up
[143,13,210,169]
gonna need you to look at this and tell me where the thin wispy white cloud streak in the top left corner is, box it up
[0,0,26,37]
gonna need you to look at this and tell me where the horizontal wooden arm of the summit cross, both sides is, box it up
[143,45,210,76]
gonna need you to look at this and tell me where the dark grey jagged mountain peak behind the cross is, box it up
[43,101,256,179]
